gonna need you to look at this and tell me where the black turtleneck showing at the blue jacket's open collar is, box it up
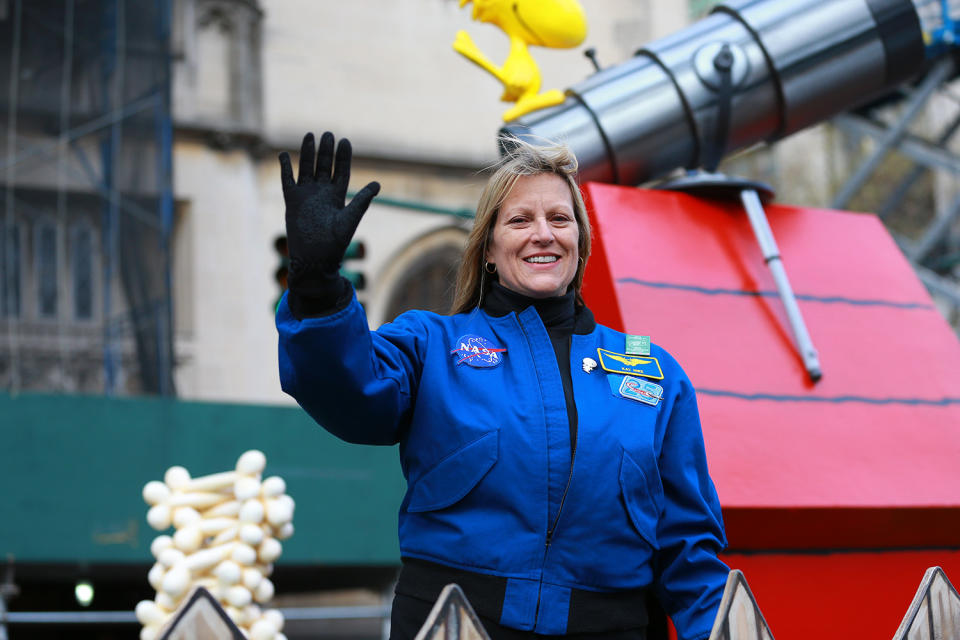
[483,282,593,456]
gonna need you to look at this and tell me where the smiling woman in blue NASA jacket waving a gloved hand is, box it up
[277,133,728,640]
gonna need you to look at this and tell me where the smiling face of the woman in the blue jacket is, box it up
[485,173,580,298]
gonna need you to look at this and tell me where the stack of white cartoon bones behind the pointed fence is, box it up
[136,450,294,640]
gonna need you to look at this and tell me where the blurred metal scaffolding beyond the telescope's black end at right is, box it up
[831,0,960,332]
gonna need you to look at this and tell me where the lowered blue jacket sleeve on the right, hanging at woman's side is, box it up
[655,381,729,640]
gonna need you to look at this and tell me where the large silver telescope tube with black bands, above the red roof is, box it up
[501,0,925,185]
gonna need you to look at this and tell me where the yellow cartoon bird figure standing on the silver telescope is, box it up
[453,0,587,120]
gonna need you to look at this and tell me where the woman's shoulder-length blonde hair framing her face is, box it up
[452,136,590,313]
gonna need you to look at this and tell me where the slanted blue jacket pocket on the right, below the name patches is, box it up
[620,447,663,549]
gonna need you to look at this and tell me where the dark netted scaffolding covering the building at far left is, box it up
[0,0,174,395]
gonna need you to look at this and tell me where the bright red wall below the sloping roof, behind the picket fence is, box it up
[723,550,960,640]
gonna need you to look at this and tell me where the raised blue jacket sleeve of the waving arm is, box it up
[276,294,425,445]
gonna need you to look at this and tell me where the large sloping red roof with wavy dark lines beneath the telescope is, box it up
[584,184,960,552]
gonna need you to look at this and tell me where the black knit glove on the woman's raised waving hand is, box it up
[280,131,380,318]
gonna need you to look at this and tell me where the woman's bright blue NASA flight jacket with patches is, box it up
[277,297,728,640]
